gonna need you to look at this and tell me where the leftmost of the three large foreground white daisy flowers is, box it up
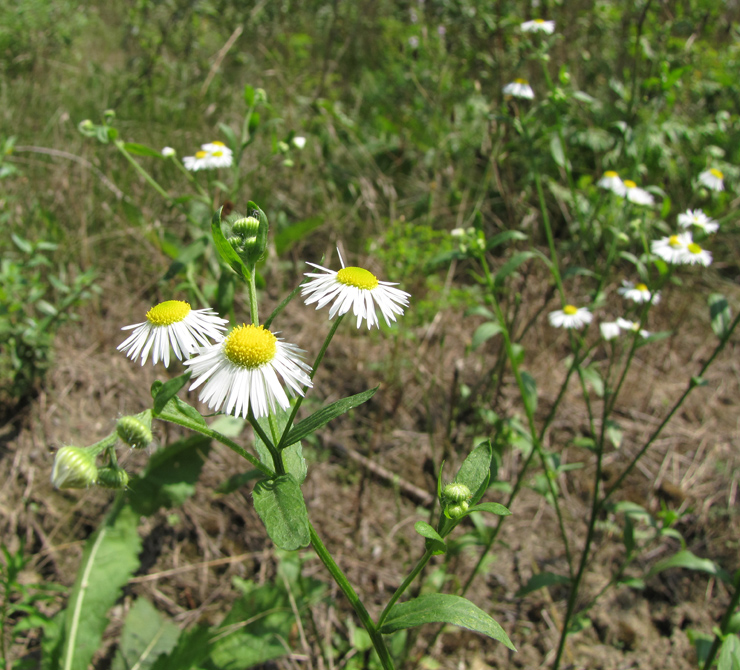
[117,300,228,367]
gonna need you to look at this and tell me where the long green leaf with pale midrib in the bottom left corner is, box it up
[61,498,141,670]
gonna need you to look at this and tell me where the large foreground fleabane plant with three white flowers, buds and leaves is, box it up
[52,202,514,668]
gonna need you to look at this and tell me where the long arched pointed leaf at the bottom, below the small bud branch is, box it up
[380,593,516,651]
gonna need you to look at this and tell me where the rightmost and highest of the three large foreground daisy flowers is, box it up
[301,254,411,330]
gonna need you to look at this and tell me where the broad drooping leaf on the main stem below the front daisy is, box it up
[252,475,310,551]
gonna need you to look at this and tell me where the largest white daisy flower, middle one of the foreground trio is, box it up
[185,324,313,419]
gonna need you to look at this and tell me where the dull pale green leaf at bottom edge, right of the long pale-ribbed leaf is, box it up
[111,598,180,670]
